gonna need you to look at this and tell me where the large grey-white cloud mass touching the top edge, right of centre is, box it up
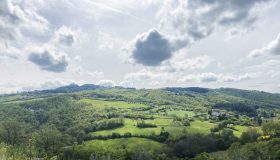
[159,0,271,41]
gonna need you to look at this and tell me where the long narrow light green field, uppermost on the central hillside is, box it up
[80,99,147,109]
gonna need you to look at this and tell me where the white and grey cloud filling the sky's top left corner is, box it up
[0,0,49,41]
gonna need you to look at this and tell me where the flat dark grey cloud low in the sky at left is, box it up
[28,48,69,72]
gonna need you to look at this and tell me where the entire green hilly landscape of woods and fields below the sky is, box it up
[0,85,280,160]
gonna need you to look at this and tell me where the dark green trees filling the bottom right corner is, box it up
[168,120,280,160]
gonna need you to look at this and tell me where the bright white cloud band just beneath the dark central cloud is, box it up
[124,54,212,86]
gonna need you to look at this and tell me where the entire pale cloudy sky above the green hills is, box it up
[0,0,280,93]
